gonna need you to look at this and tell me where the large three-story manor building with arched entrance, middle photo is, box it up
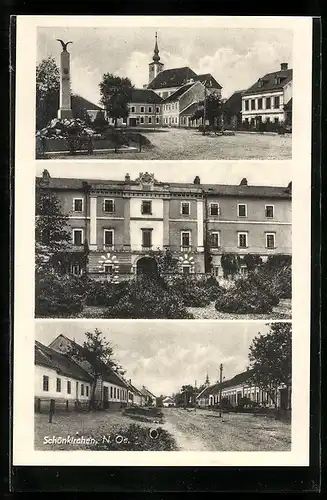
[36,170,292,280]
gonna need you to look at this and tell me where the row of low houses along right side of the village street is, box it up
[196,370,289,409]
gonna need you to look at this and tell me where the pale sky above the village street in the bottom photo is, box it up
[35,320,269,396]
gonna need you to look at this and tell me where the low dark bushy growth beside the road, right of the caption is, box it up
[89,424,177,451]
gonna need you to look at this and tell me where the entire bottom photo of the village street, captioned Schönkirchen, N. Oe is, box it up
[34,320,292,452]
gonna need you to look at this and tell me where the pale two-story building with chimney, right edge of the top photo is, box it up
[242,63,293,127]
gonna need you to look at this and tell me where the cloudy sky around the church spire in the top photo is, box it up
[37,26,292,104]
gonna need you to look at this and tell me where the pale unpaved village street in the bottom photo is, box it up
[163,408,291,451]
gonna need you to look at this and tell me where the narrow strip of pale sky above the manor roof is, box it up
[36,160,292,187]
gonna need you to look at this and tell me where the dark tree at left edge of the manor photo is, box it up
[35,186,71,269]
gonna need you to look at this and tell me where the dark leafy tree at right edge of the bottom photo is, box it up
[249,323,292,408]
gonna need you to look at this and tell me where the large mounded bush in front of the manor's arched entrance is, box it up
[105,277,193,319]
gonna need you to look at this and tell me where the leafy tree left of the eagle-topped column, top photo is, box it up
[36,56,60,130]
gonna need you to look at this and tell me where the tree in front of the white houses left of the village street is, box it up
[67,328,120,409]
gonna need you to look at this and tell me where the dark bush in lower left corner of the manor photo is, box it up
[35,272,84,317]
